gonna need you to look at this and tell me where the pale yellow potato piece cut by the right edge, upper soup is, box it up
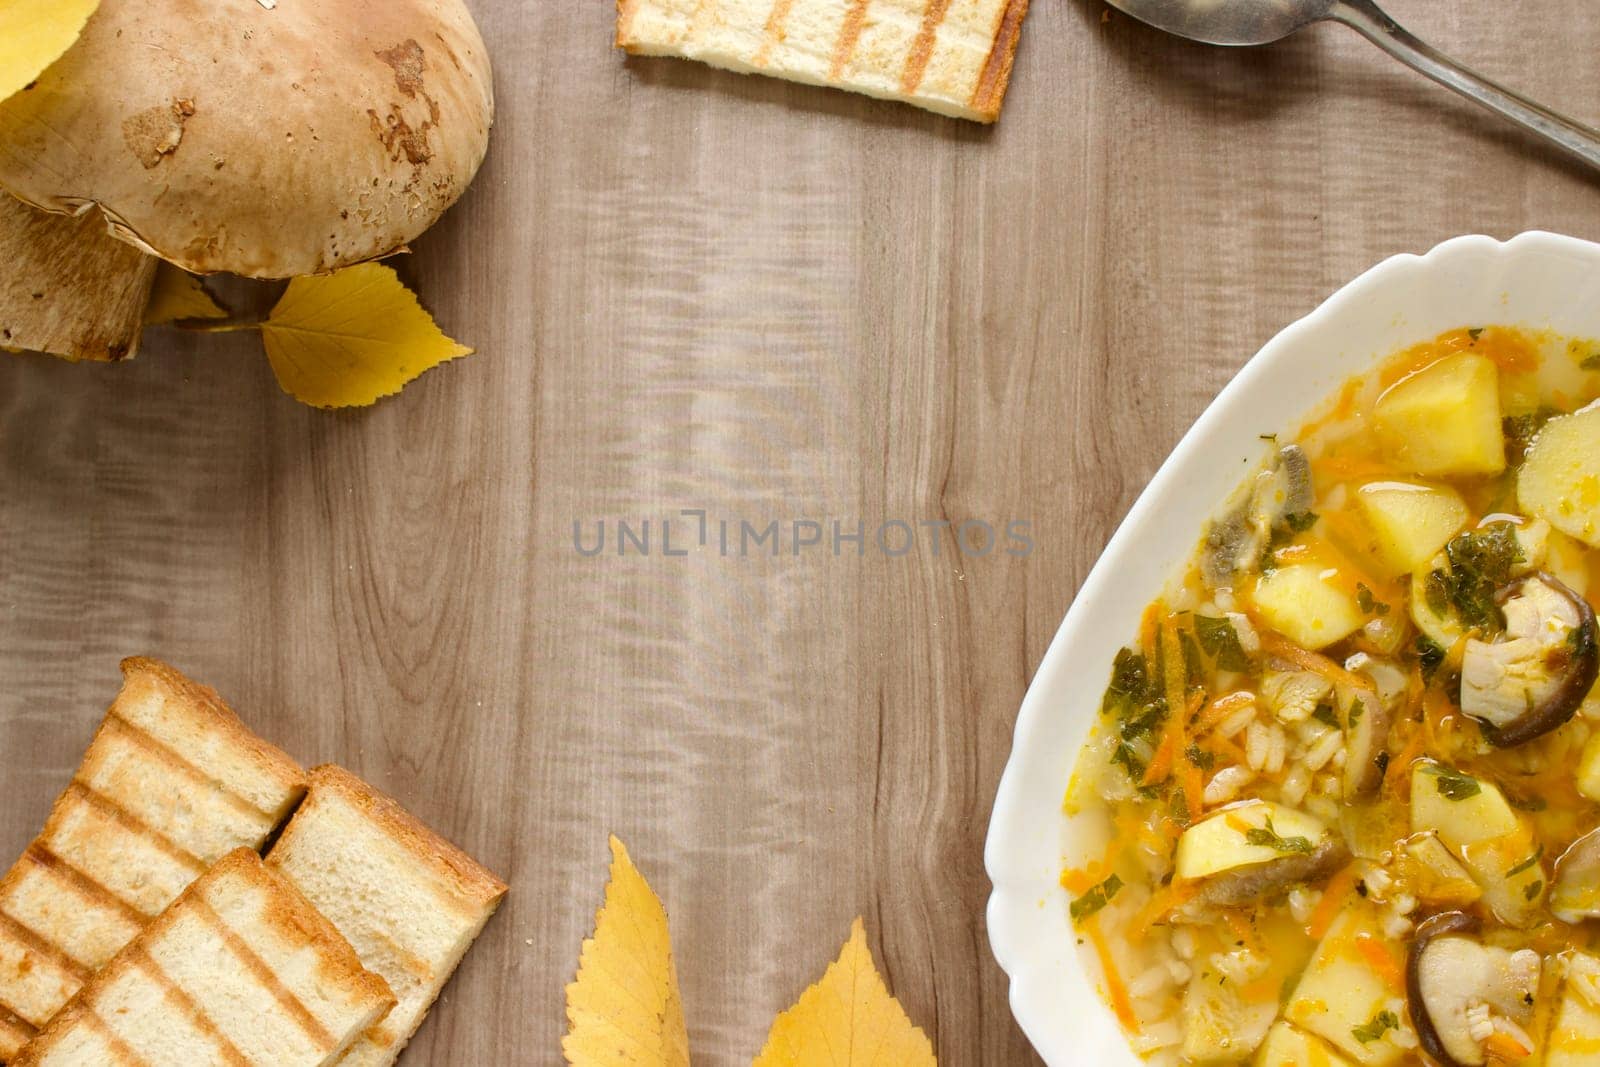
[1517,405,1600,549]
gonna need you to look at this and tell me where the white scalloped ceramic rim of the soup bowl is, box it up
[984,232,1600,1067]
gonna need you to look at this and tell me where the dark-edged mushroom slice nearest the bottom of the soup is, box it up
[1406,912,1539,1067]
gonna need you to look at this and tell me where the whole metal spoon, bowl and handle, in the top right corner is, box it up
[1107,0,1600,170]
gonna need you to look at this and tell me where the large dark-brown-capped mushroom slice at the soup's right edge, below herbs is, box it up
[1461,571,1600,747]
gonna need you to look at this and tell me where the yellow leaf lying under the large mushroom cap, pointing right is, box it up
[261,262,472,408]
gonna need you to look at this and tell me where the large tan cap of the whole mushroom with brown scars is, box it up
[0,0,493,277]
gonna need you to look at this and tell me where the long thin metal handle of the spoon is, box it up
[1328,0,1600,170]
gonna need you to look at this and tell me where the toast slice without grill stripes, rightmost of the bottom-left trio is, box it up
[267,766,506,1067]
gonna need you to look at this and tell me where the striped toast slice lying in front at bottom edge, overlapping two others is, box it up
[11,848,394,1067]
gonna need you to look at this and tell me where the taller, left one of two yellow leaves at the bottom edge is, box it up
[562,837,690,1067]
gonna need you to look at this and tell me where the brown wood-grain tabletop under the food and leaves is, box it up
[0,0,1600,1064]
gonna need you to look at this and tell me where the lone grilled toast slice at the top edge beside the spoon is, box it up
[616,0,1027,122]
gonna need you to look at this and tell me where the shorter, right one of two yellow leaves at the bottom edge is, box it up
[754,918,938,1067]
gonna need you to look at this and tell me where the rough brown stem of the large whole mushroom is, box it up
[0,192,157,362]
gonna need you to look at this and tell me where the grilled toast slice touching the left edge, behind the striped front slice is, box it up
[0,659,306,1064]
